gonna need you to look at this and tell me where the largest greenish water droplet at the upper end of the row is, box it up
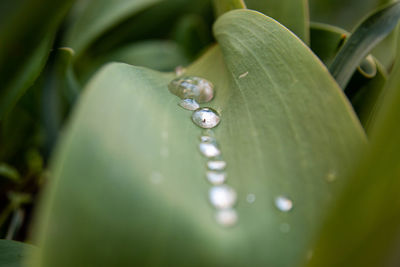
[168,76,214,103]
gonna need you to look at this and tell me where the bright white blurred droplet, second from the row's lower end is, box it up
[209,185,237,209]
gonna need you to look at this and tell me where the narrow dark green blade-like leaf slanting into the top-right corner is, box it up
[329,1,400,88]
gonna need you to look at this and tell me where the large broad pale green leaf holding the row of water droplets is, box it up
[32,10,366,266]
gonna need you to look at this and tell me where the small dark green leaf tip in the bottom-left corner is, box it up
[0,239,37,267]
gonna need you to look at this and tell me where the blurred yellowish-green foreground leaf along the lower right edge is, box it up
[309,30,400,266]
